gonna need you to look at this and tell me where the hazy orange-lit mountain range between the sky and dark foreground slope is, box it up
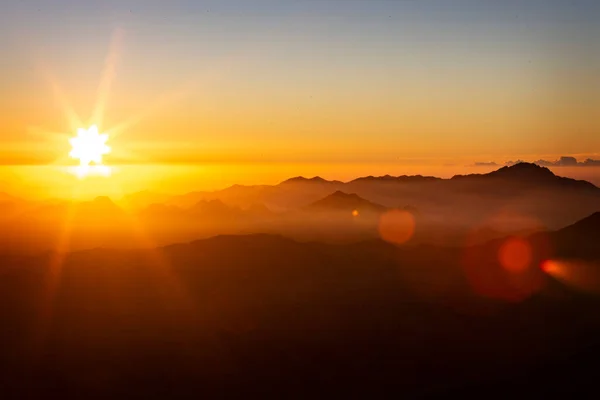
[0,163,600,251]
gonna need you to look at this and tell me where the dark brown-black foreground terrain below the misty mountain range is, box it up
[0,214,600,399]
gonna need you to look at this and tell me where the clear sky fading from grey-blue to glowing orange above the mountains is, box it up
[0,0,600,198]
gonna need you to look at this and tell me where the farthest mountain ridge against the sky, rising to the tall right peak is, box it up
[157,163,600,222]
